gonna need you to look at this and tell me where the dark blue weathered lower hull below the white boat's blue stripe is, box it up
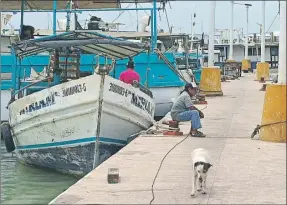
[16,138,124,176]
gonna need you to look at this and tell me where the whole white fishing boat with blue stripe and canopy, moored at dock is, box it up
[1,1,158,175]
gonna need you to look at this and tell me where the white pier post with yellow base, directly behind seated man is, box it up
[199,1,223,96]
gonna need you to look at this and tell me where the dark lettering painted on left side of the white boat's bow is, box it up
[20,83,87,115]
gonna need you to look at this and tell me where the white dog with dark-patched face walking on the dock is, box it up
[191,148,212,196]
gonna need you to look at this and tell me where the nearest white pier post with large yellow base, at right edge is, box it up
[259,1,287,143]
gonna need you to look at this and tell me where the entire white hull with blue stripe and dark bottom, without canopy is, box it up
[9,74,155,176]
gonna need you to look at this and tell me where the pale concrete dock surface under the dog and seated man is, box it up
[51,74,286,204]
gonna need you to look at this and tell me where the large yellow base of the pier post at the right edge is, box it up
[259,84,287,142]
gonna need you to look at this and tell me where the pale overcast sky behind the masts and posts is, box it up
[2,1,279,33]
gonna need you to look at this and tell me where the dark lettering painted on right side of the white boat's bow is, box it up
[109,83,153,115]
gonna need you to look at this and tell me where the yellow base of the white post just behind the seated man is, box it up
[199,67,223,96]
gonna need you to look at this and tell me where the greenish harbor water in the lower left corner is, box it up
[1,140,78,204]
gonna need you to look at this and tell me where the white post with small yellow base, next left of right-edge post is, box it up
[256,1,269,81]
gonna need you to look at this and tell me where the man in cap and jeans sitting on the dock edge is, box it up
[170,83,205,137]
